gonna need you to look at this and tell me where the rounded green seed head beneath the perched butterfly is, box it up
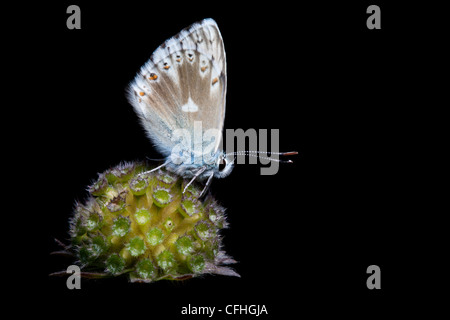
[66,163,237,282]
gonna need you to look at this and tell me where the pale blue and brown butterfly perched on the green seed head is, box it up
[128,19,296,198]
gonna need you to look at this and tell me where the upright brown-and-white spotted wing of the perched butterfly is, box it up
[128,19,227,161]
